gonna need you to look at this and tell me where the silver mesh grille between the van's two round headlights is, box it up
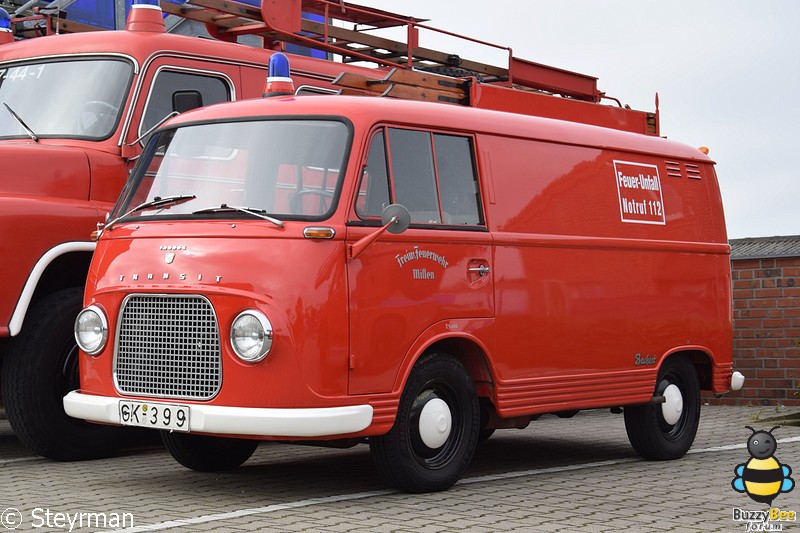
[114,294,222,400]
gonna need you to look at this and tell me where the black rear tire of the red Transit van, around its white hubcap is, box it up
[624,356,700,461]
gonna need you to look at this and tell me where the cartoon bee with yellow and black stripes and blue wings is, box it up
[731,426,794,506]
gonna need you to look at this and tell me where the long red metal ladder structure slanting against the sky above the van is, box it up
[161,0,604,102]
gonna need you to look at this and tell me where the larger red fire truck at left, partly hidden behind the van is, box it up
[0,2,412,460]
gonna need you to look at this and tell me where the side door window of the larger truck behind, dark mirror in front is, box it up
[139,70,231,134]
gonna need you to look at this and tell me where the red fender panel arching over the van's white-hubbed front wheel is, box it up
[392,318,496,397]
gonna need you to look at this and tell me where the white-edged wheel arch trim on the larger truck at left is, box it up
[9,242,96,337]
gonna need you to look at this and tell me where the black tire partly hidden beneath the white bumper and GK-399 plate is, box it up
[161,431,259,472]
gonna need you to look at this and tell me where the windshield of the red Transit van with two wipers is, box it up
[115,118,350,223]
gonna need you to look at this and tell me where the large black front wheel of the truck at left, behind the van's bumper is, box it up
[0,288,125,461]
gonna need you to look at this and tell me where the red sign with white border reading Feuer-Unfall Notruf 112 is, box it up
[614,160,667,225]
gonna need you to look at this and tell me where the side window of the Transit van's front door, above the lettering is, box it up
[356,128,483,226]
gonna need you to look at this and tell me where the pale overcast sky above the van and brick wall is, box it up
[354,0,800,238]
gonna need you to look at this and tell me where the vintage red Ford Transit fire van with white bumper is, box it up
[64,54,742,492]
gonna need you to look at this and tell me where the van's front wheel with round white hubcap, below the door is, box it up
[369,353,480,492]
